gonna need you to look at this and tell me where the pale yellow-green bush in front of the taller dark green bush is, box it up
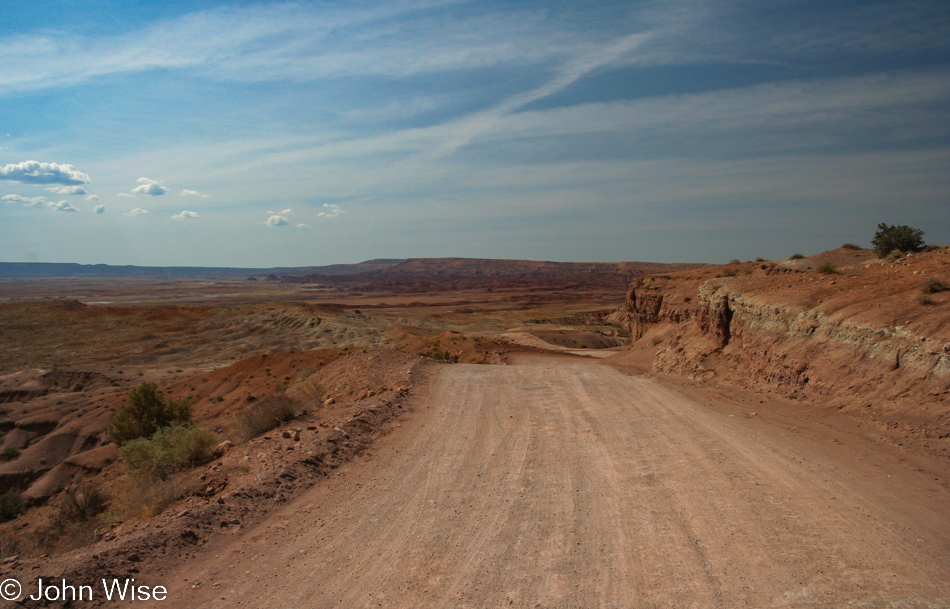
[119,425,218,481]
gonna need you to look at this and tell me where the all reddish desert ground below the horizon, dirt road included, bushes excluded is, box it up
[0,248,950,608]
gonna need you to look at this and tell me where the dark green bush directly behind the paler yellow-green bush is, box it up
[106,383,191,446]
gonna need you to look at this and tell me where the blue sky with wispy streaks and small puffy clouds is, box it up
[0,0,950,267]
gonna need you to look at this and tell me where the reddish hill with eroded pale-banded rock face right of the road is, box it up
[612,247,950,455]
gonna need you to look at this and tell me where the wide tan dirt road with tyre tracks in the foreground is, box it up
[137,362,950,609]
